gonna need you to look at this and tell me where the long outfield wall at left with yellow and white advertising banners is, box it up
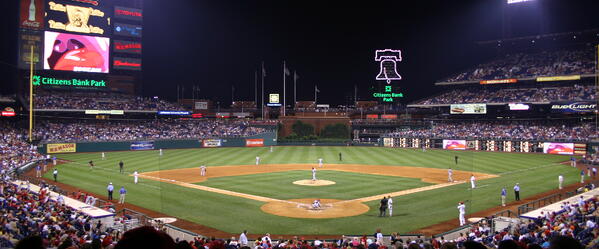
[38,132,277,154]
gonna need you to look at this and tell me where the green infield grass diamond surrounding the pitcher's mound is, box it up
[198,171,431,200]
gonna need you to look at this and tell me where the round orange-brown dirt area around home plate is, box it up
[260,199,369,219]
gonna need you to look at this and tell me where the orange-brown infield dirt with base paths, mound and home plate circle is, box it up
[139,164,497,219]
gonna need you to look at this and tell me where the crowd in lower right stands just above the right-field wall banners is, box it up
[387,120,599,141]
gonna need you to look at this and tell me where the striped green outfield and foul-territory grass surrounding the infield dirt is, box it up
[45,146,580,234]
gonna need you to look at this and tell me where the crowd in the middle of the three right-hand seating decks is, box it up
[415,85,597,105]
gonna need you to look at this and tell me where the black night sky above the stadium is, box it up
[0,0,599,105]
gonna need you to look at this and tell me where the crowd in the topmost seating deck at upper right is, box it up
[442,48,595,82]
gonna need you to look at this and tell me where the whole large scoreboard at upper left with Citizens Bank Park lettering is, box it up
[17,0,143,92]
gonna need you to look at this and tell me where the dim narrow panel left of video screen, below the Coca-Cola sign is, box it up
[19,29,44,70]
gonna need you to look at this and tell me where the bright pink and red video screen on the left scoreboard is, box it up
[44,31,110,73]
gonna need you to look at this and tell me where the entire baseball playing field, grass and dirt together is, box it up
[44,146,580,235]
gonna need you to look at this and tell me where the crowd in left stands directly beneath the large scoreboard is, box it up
[34,91,185,111]
